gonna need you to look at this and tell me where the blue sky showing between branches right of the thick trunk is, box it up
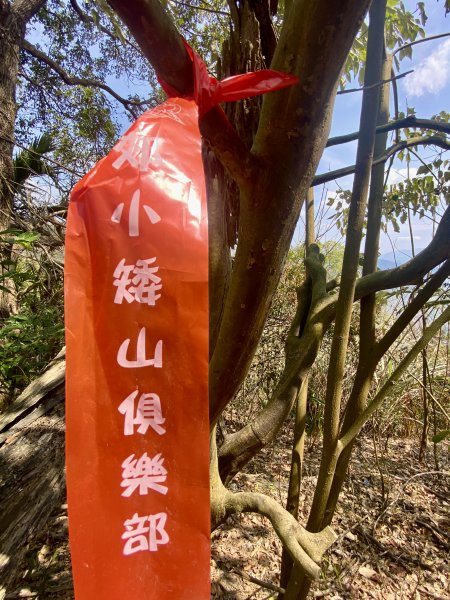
[300,0,450,254]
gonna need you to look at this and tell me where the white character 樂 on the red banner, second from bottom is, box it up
[120,452,168,498]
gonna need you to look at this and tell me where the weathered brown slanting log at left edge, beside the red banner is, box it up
[0,350,65,598]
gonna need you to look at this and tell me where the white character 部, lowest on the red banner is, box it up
[122,513,169,556]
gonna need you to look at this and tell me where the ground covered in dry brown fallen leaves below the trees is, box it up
[5,420,450,600]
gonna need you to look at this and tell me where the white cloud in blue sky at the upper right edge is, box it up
[403,40,450,97]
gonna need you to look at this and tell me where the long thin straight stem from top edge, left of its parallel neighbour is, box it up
[320,0,387,454]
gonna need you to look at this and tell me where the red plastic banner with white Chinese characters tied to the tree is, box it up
[65,39,297,600]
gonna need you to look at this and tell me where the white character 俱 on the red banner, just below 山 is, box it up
[119,390,166,435]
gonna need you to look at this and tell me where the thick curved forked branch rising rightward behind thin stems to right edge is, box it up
[219,207,450,482]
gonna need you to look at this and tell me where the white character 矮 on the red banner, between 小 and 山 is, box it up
[113,257,162,306]
